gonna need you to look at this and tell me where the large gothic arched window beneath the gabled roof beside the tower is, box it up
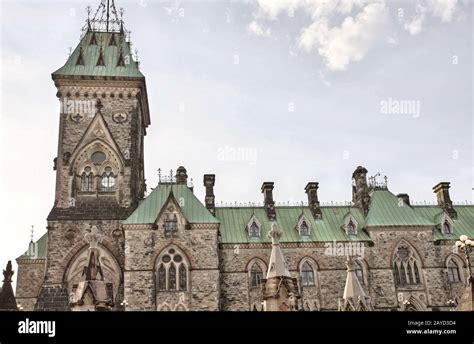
[157,248,189,291]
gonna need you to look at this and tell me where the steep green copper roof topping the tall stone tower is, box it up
[53,31,144,78]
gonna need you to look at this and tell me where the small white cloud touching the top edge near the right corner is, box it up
[404,0,458,35]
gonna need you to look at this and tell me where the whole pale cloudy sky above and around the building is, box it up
[0,0,474,286]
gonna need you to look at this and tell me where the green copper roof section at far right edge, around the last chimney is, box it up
[413,205,474,240]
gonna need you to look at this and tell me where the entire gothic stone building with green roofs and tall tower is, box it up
[12,1,474,311]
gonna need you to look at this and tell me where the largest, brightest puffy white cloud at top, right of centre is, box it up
[299,2,387,71]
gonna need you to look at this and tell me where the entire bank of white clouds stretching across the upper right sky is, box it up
[248,0,459,71]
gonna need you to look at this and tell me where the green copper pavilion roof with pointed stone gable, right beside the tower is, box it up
[123,184,219,225]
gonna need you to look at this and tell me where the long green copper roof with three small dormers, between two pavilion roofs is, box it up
[216,207,370,243]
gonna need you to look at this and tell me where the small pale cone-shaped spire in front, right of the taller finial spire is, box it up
[339,257,373,311]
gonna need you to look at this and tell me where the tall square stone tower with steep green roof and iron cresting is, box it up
[25,0,150,310]
